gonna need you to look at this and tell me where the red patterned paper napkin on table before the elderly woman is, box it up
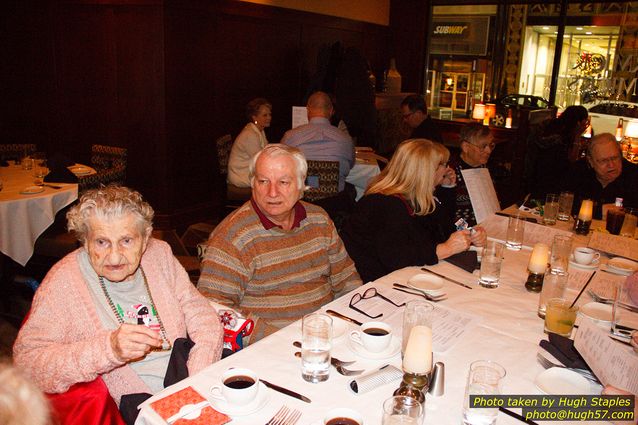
[151,387,231,425]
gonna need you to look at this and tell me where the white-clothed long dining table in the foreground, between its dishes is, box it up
[136,212,631,425]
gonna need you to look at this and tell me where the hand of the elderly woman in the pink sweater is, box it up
[111,323,162,363]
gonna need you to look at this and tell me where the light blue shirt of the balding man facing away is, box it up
[281,117,354,191]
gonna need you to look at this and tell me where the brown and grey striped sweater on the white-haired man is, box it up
[197,201,361,342]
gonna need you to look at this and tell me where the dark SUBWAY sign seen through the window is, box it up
[430,15,490,56]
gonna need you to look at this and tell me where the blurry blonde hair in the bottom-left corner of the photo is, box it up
[0,359,52,425]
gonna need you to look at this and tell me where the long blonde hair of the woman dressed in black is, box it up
[366,139,450,215]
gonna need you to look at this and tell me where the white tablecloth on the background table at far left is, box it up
[0,165,78,266]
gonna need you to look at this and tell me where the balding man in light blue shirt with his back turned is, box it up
[281,91,354,192]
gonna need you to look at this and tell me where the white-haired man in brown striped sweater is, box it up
[197,144,361,343]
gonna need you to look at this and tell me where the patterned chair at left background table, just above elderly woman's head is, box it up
[78,145,127,192]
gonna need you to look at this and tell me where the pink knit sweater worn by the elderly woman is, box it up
[13,239,223,405]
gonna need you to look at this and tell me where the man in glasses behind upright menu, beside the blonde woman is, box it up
[448,123,495,226]
